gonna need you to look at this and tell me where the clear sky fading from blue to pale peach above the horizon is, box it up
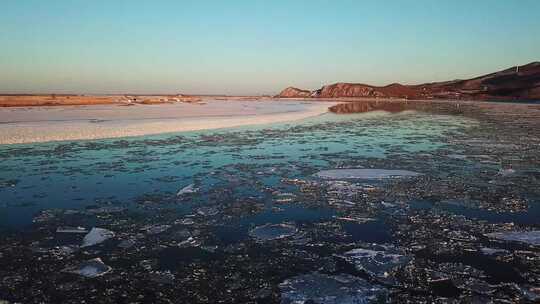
[0,0,540,94]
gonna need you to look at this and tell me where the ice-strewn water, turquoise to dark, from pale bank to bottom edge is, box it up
[0,102,540,303]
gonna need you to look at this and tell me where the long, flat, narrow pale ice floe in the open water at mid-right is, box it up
[315,169,422,179]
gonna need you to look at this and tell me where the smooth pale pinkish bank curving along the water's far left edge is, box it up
[0,100,335,144]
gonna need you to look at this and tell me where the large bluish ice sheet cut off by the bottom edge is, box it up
[279,273,387,304]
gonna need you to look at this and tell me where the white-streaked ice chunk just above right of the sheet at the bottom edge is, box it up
[341,246,412,281]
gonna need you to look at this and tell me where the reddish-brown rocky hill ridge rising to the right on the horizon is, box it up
[276,62,540,100]
